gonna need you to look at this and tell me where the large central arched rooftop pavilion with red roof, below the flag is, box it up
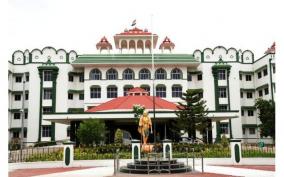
[114,27,158,53]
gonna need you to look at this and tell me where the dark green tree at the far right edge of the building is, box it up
[255,99,275,140]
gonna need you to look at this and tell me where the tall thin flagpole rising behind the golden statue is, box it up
[151,14,156,147]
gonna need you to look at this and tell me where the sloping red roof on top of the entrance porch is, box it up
[86,88,178,112]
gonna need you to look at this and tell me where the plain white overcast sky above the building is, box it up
[5,0,279,59]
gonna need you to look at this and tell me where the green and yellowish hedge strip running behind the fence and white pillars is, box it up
[19,143,275,162]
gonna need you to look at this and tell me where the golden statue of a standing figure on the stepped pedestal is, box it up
[138,110,153,145]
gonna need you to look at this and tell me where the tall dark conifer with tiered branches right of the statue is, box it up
[174,89,208,140]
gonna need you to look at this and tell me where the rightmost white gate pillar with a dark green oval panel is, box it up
[230,139,242,165]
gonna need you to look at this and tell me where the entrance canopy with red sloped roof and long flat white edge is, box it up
[43,87,239,124]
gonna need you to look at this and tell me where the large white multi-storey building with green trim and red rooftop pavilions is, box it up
[8,27,275,143]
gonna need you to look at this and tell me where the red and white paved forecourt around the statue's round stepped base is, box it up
[9,158,275,177]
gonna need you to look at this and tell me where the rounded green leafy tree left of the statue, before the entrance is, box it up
[77,119,105,147]
